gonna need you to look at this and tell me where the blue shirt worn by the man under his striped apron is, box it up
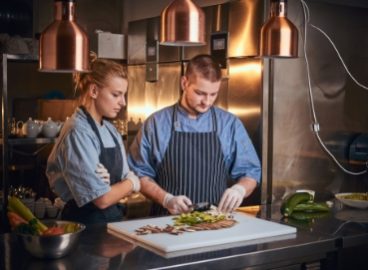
[128,103,261,183]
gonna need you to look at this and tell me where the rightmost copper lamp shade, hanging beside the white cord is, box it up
[260,0,298,58]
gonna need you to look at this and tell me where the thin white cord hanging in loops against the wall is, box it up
[300,0,368,175]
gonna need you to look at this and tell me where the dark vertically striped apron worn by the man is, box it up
[151,105,228,215]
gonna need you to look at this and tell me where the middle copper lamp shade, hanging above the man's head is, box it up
[160,0,206,46]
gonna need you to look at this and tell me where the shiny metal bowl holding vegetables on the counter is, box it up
[17,221,86,259]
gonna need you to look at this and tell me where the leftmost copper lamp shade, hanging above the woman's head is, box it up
[39,0,90,72]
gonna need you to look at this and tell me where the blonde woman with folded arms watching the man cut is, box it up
[46,55,140,224]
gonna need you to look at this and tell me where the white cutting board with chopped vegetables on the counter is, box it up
[107,213,296,253]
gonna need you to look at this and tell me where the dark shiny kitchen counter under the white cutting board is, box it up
[0,205,368,270]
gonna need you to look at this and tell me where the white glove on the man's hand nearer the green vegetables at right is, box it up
[218,184,246,213]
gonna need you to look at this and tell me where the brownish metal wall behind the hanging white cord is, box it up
[270,1,368,202]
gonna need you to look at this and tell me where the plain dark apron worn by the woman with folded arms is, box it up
[62,106,123,224]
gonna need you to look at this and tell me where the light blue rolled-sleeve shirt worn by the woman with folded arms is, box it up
[46,108,129,207]
